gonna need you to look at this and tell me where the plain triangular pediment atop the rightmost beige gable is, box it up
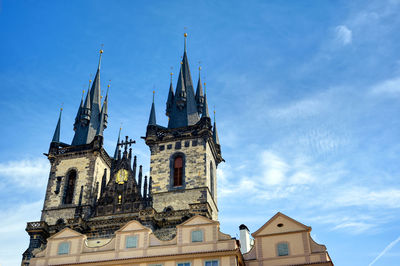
[252,212,311,237]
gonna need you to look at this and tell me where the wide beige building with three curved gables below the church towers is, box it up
[30,216,244,266]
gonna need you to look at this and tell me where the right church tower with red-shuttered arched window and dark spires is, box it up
[145,33,223,220]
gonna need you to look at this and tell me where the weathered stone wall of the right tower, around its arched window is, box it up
[150,138,218,220]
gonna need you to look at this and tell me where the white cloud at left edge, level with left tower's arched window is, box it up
[0,158,50,188]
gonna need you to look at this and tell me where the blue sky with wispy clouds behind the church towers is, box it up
[0,0,400,266]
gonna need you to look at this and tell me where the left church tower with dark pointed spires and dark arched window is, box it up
[41,50,112,225]
